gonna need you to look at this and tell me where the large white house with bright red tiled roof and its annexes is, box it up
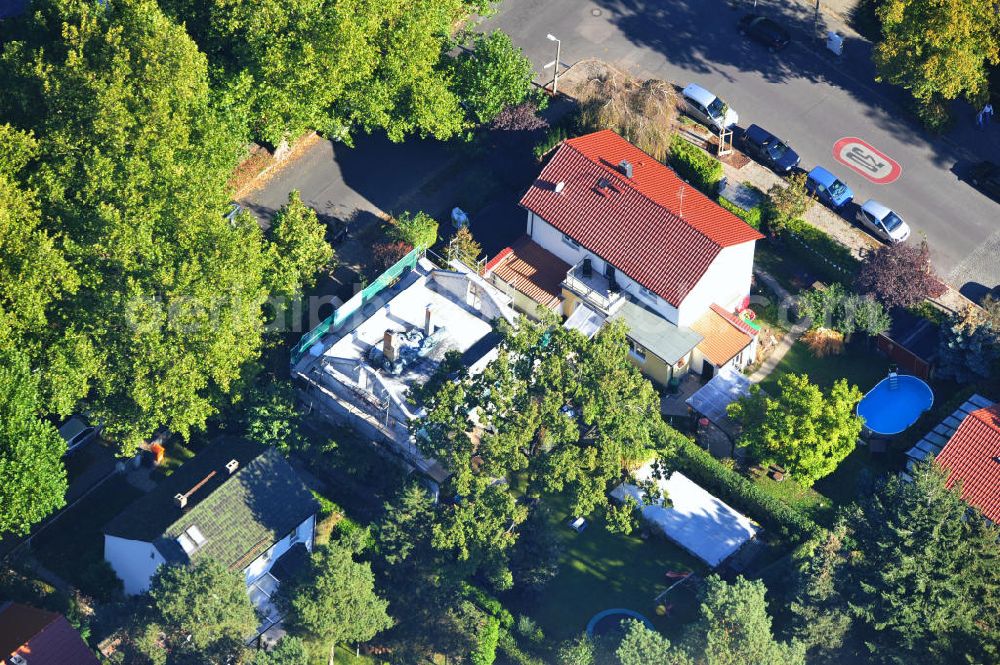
[486,130,763,383]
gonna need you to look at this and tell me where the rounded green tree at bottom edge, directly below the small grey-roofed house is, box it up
[145,559,258,665]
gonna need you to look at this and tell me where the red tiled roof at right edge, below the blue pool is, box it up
[937,404,1000,524]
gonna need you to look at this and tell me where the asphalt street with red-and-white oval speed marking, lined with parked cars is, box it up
[482,0,1000,297]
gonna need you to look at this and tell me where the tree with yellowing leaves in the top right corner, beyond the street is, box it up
[874,0,1000,126]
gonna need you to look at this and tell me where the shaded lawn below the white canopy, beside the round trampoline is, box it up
[511,490,706,641]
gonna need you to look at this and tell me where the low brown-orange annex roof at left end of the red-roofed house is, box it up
[486,236,570,309]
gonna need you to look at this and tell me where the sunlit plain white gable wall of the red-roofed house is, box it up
[674,241,756,326]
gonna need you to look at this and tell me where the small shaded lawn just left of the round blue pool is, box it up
[760,340,889,394]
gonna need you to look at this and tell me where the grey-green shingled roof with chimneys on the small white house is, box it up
[104,439,319,569]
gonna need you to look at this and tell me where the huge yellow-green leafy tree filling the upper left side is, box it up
[0,0,322,454]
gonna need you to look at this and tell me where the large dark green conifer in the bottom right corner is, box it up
[838,465,1000,664]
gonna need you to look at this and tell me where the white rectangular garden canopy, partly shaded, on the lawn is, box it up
[611,464,759,568]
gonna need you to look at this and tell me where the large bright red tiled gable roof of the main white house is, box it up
[521,130,763,306]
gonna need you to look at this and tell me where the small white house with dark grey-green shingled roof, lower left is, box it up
[104,439,319,627]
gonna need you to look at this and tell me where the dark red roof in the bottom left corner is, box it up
[0,603,99,665]
